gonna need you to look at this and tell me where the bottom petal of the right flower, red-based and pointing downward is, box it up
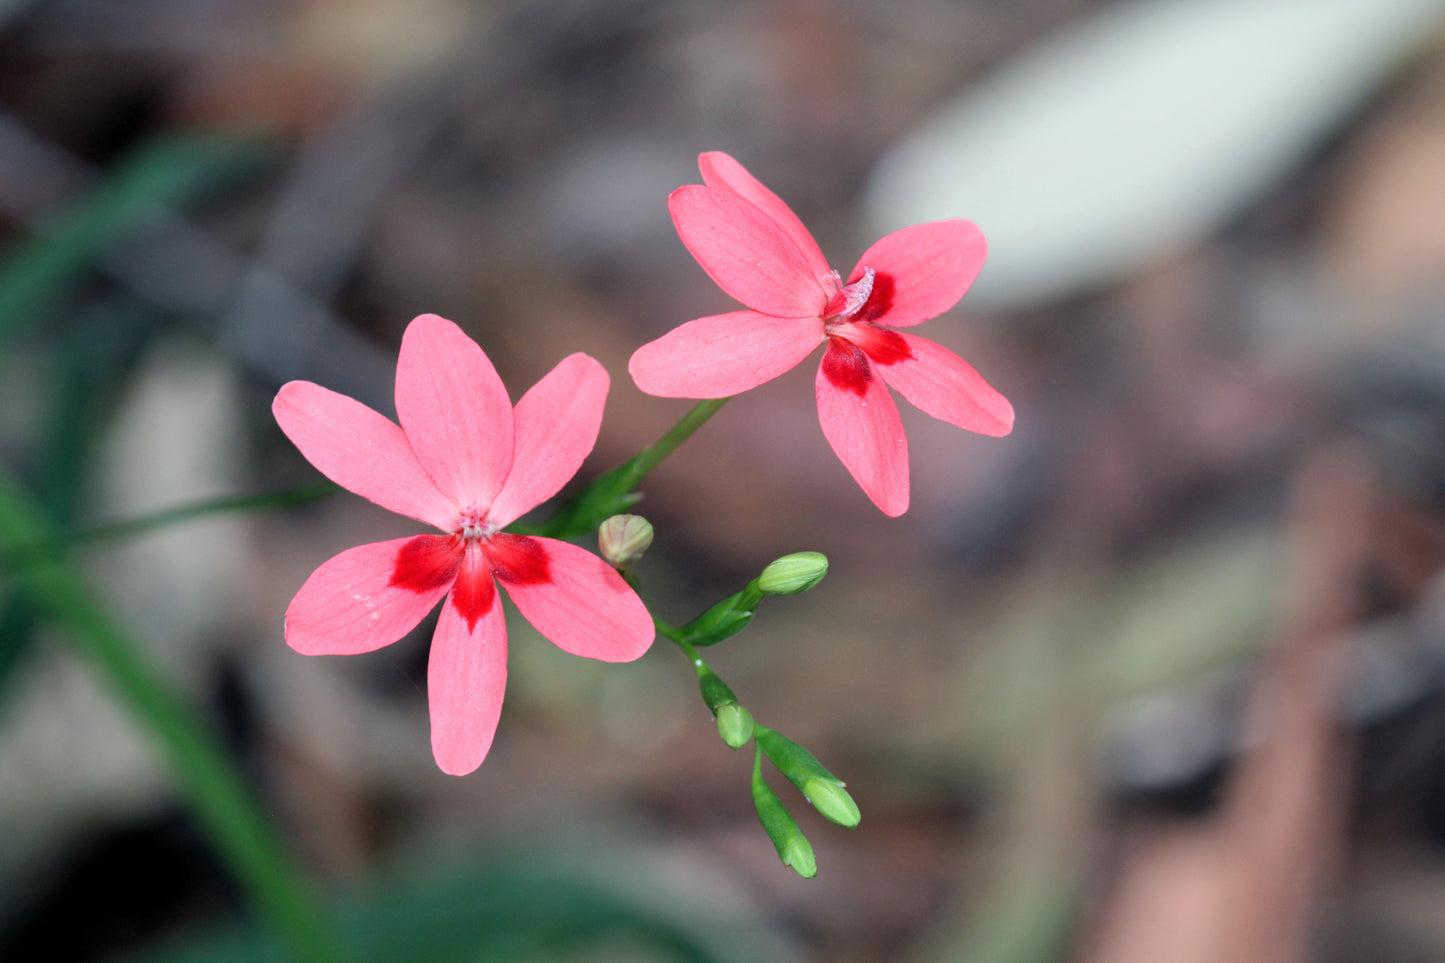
[815,338,909,518]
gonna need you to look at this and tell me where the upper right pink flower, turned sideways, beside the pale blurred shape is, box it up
[627,152,1013,516]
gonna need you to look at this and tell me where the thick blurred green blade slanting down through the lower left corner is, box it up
[0,471,348,963]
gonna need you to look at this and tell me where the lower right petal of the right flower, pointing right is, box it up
[874,331,1013,438]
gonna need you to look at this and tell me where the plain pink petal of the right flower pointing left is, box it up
[627,311,822,398]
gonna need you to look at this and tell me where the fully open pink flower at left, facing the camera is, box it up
[272,314,653,775]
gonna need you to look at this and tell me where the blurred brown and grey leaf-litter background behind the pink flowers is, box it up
[0,0,1445,963]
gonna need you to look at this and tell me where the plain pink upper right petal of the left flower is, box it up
[487,353,610,528]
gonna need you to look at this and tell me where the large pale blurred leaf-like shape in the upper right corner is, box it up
[867,0,1445,308]
